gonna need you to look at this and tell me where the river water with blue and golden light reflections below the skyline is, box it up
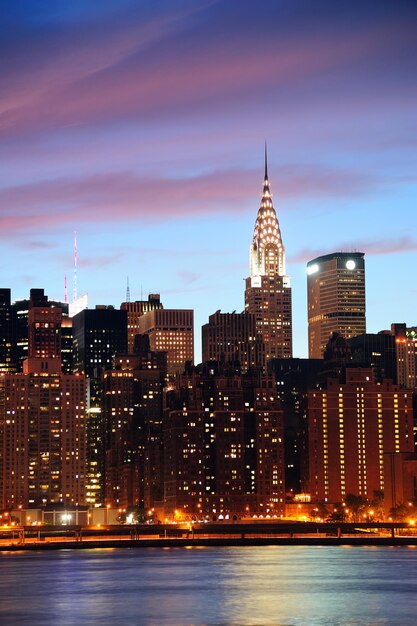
[0,546,417,626]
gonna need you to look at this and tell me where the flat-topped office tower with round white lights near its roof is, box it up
[307,252,366,359]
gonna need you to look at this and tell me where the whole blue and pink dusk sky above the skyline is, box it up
[0,0,417,362]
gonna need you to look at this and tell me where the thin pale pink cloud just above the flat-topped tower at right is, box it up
[288,237,417,264]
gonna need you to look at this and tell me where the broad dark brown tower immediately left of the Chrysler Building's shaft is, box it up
[202,311,264,373]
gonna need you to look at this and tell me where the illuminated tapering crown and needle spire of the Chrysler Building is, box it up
[249,146,285,278]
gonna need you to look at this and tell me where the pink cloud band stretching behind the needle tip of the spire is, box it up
[0,166,385,236]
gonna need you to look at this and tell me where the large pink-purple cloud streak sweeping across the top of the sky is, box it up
[0,11,406,140]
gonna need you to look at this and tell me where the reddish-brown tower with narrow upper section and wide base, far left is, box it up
[0,290,86,507]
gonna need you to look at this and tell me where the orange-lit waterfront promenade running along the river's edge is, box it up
[0,522,417,552]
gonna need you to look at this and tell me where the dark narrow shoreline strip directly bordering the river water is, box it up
[0,536,417,553]
